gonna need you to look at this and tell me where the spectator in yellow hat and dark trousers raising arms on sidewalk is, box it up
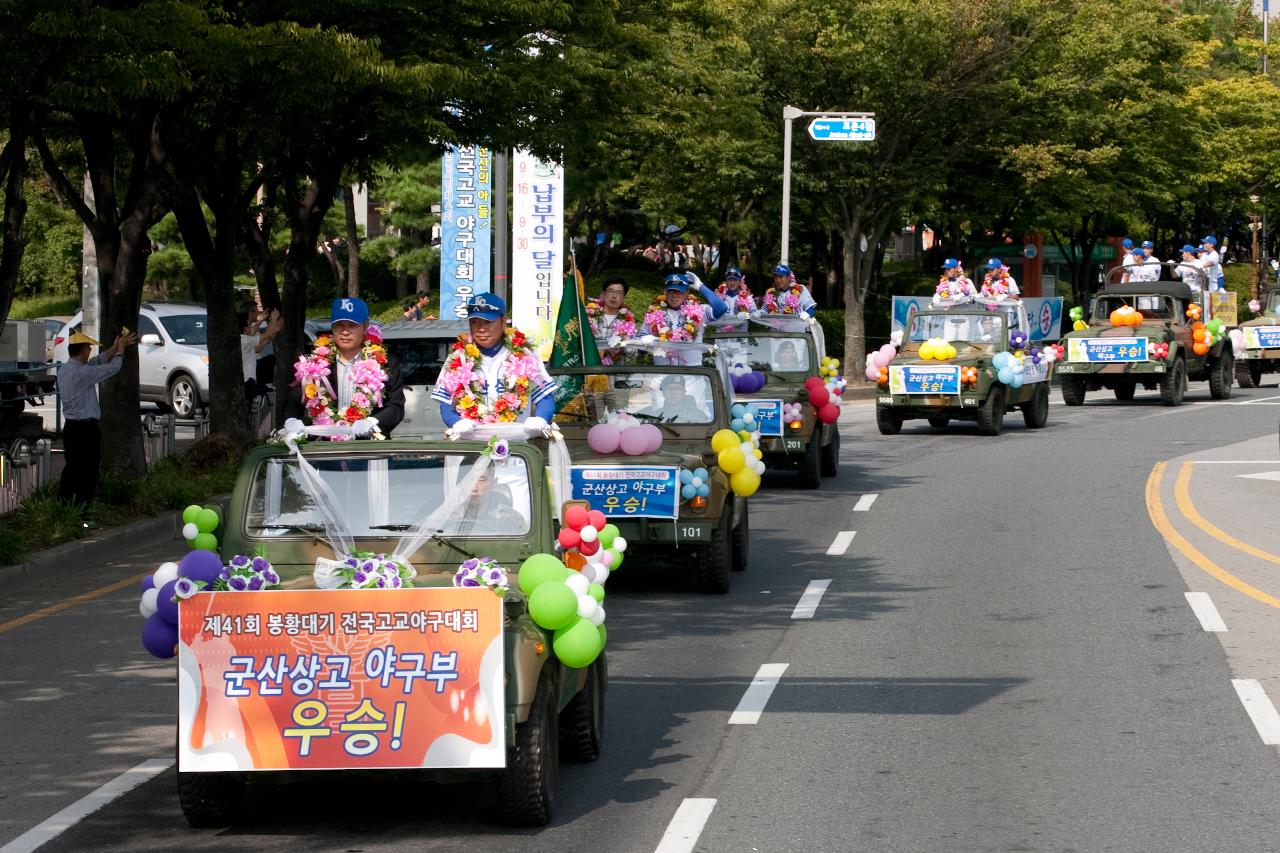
[58,329,138,522]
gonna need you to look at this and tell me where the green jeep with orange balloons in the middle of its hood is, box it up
[1059,275,1235,406]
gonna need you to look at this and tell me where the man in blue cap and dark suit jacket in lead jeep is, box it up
[284,296,404,437]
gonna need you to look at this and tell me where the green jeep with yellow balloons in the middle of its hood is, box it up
[876,300,1053,435]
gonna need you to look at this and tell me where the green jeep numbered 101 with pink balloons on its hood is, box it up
[550,342,749,593]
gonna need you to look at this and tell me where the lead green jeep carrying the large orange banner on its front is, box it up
[178,427,608,826]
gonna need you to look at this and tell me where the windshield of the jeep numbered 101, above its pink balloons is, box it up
[552,371,716,425]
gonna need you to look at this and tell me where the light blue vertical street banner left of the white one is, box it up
[438,145,493,320]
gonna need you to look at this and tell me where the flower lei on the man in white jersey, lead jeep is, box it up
[440,329,541,424]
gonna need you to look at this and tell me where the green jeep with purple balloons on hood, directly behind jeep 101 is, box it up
[705,314,840,489]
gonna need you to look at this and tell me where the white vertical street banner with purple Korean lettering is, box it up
[511,150,564,361]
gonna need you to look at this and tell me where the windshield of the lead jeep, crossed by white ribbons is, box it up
[246,451,532,539]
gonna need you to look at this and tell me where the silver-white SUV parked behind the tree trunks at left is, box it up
[54,302,209,418]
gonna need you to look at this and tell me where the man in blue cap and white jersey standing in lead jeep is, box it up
[431,293,556,435]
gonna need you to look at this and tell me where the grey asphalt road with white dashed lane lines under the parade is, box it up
[0,382,1280,853]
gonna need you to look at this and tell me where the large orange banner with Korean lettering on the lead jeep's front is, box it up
[178,588,506,772]
